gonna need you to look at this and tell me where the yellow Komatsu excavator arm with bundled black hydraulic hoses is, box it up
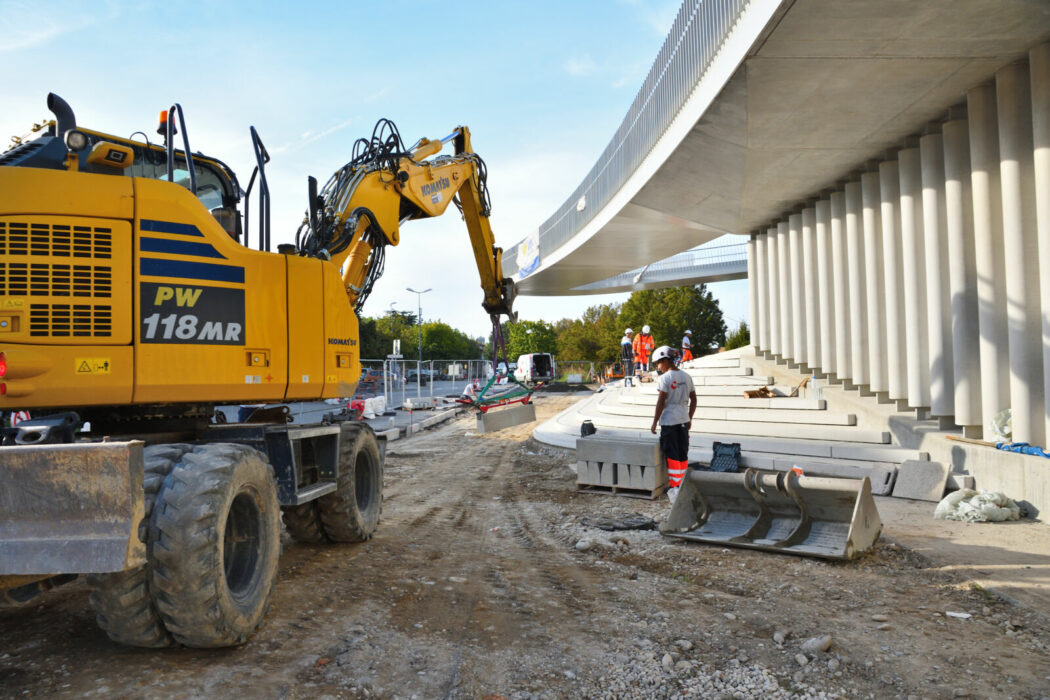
[296,120,517,328]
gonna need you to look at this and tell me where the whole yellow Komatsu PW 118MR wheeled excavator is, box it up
[0,94,515,648]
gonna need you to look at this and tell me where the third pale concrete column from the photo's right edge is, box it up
[966,84,1010,440]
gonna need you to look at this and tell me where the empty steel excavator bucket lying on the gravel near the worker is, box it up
[660,469,882,559]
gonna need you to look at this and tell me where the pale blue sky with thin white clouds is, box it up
[0,0,748,348]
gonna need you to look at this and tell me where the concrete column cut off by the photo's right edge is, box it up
[1028,44,1050,440]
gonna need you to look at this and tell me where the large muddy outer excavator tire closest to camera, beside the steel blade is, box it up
[150,443,280,649]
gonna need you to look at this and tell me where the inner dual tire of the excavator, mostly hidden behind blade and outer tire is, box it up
[87,444,192,649]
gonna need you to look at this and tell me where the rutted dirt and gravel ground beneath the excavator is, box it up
[0,397,1050,698]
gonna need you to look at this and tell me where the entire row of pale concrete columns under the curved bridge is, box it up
[748,44,1050,445]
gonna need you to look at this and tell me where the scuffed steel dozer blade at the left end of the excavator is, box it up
[0,442,146,582]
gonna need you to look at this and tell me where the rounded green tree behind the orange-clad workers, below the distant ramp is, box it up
[620,284,726,355]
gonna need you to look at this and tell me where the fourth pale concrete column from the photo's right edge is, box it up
[944,120,984,438]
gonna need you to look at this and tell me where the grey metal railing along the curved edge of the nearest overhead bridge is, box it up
[504,0,754,271]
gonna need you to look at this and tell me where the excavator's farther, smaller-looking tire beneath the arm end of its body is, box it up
[317,423,383,542]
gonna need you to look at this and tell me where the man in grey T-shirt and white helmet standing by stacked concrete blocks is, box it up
[649,345,696,503]
